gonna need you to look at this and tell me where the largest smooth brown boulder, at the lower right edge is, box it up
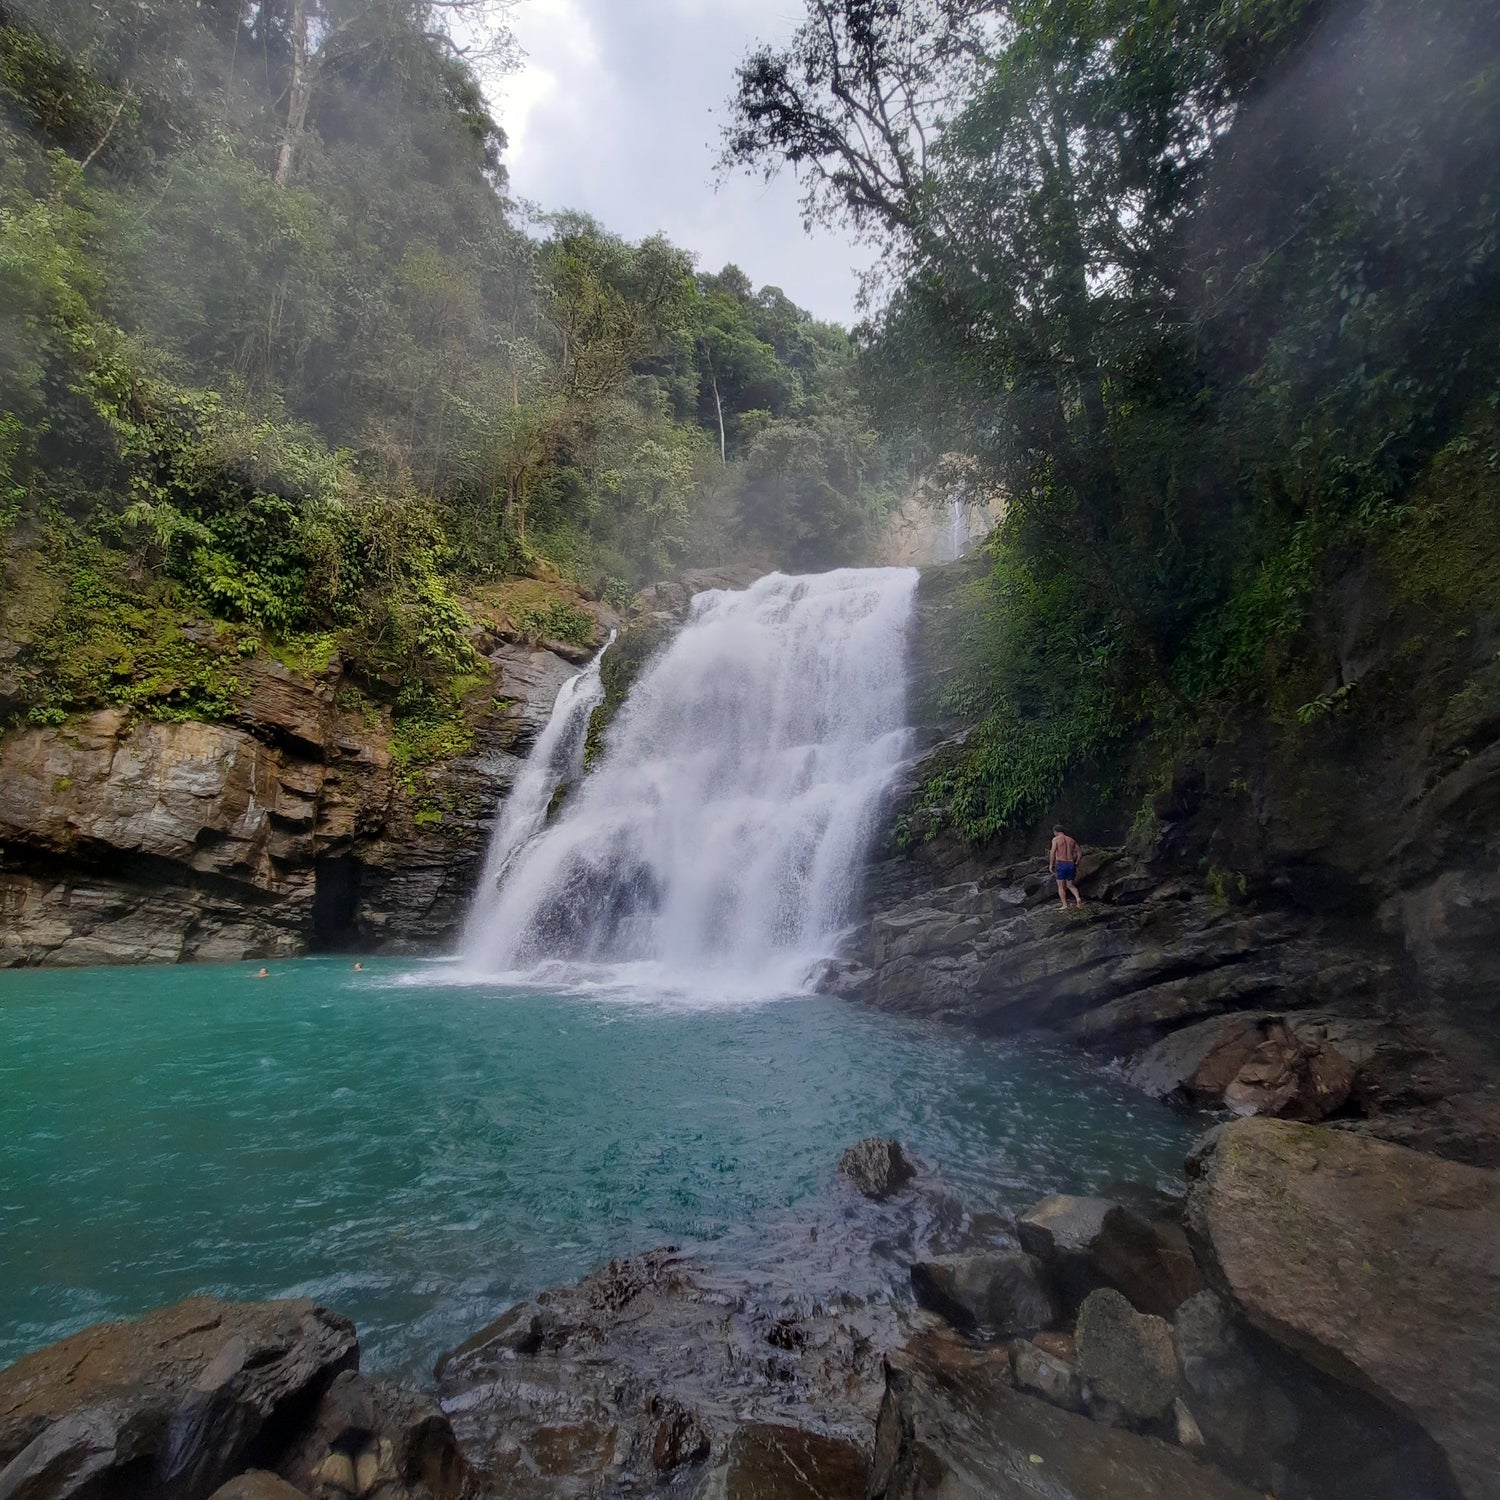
[1188,1119,1500,1500]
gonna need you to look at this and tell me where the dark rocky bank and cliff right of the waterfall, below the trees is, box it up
[822,549,1500,1164]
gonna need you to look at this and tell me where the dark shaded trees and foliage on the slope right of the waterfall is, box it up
[726,0,1500,842]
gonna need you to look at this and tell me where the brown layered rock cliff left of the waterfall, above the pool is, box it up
[0,645,576,965]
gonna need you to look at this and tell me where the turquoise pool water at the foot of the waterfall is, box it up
[0,960,1194,1376]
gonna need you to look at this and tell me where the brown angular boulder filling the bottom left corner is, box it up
[0,1298,359,1500]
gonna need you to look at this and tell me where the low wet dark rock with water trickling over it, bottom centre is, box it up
[437,1242,902,1500]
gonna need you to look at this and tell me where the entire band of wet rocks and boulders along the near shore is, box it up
[0,1119,1500,1500]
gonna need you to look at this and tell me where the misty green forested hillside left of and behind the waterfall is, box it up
[0,0,899,723]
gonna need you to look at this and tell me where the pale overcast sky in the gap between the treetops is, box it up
[494,0,870,324]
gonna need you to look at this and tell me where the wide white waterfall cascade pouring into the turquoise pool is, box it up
[465,569,917,993]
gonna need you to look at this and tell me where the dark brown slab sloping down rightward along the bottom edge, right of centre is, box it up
[869,1340,1259,1500]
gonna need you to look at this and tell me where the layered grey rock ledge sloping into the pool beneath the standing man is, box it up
[816,849,1500,1167]
